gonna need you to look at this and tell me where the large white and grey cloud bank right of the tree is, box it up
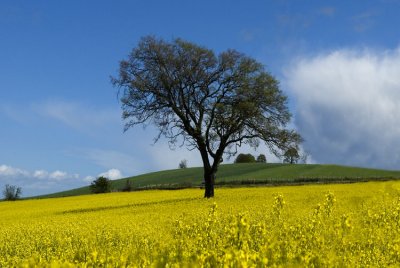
[285,48,400,169]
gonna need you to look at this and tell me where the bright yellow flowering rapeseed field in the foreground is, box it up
[0,181,400,267]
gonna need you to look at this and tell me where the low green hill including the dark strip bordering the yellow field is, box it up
[32,163,400,199]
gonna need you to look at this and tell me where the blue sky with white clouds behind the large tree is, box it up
[0,0,400,196]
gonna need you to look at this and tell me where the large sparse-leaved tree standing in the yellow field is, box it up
[112,36,301,198]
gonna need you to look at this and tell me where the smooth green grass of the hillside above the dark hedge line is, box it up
[38,163,400,197]
